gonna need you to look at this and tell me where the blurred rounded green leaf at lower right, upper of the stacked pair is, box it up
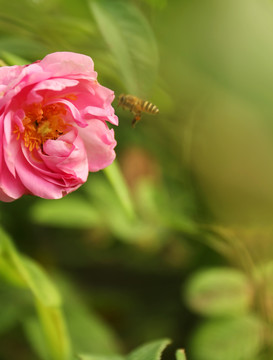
[185,267,252,316]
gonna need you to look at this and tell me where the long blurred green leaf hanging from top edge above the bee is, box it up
[88,0,158,96]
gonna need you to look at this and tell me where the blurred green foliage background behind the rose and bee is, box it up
[0,0,273,360]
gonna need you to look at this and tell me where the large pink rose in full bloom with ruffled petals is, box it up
[0,52,118,201]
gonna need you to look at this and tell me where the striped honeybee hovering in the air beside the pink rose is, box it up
[118,94,159,127]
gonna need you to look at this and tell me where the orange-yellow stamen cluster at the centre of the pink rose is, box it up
[14,103,71,151]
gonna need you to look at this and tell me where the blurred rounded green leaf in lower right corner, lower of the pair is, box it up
[191,316,263,360]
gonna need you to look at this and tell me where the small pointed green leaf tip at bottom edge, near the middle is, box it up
[126,339,170,360]
